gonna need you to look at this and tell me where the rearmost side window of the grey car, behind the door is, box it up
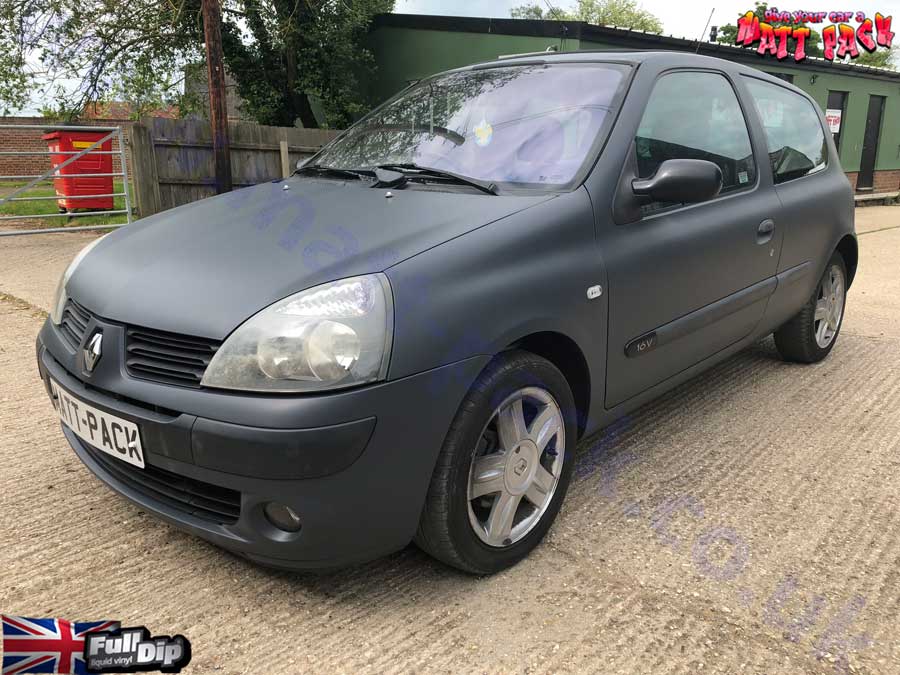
[747,78,828,183]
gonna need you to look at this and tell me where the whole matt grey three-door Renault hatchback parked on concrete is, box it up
[37,52,857,574]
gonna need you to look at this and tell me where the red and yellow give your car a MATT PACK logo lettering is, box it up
[735,7,894,61]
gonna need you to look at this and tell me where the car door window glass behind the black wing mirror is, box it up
[634,72,756,213]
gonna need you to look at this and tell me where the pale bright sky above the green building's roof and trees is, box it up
[394,0,900,44]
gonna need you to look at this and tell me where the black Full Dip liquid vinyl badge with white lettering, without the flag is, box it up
[84,626,191,673]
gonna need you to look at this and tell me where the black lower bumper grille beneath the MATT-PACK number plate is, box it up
[84,445,241,525]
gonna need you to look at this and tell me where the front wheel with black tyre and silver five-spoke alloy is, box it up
[415,351,576,574]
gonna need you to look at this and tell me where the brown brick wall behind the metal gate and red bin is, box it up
[0,117,132,176]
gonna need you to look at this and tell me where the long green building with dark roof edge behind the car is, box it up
[369,14,900,196]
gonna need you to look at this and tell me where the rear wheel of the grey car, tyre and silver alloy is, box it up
[775,252,847,363]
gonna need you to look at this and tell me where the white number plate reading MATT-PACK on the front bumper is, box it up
[50,379,144,469]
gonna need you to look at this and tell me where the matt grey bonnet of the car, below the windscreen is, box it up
[67,177,551,339]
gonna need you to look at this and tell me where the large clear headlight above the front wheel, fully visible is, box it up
[202,274,394,392]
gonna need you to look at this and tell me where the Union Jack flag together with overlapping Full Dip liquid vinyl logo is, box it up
[2,615,191,675]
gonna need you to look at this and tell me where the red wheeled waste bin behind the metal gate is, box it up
[43,129,113,211]
